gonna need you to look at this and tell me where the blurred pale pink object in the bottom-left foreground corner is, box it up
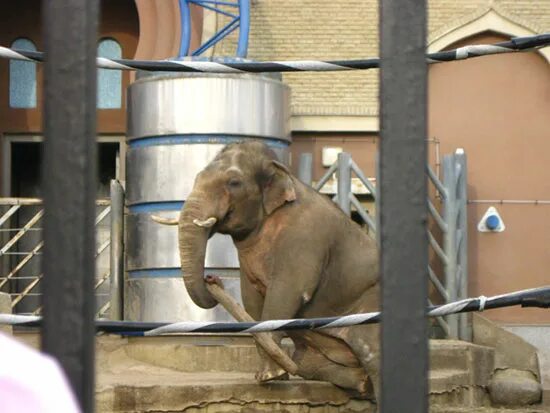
[0,333,80,413]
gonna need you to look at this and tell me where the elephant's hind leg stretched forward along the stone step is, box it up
[293,344,369,397]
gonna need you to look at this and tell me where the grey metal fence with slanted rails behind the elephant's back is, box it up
[298,149,471,341]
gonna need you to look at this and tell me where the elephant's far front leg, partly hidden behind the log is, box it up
[241,277,288,383]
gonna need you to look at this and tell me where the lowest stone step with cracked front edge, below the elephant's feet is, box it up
[96,362,487,413]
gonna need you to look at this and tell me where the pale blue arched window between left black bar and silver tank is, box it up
[97,39,122,109]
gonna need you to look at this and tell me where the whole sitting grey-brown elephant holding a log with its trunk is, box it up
[179,141,379,395]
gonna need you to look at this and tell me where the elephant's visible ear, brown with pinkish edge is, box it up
[261,160,296,215]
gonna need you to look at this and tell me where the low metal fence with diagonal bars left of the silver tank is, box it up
[0,180,124,320]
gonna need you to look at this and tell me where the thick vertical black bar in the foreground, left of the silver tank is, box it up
[42,0,99,413]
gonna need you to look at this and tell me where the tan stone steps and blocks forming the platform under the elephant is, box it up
[14,335,504,413]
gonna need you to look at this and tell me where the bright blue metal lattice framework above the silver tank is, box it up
[179,0,250,57]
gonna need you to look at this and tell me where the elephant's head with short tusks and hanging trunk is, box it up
[178,141,296,308]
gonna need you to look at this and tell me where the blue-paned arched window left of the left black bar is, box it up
[10,38,36,109]
